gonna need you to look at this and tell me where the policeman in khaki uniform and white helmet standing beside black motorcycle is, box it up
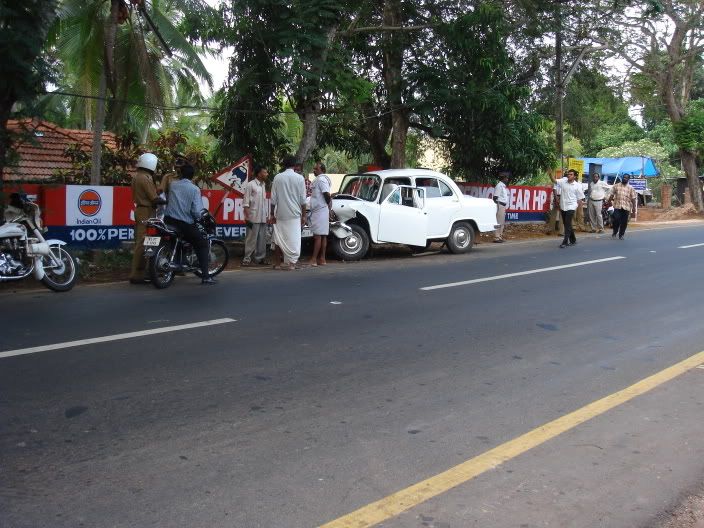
[130,153,165,284]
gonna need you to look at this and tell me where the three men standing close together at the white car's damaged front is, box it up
[242,157,332,271]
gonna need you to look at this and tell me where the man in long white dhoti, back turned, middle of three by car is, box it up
[270,157,306,270]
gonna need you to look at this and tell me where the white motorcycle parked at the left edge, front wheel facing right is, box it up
[0,193,78,292]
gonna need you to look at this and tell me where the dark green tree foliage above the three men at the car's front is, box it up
[212,0,354,168]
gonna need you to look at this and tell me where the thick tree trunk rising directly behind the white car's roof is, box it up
[383,0,409,168]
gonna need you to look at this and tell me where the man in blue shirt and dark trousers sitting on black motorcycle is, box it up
[164,164,216,284]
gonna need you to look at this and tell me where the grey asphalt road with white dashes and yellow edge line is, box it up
[0,225,704,528]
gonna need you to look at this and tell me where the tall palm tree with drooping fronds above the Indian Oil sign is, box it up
[48,0,212,184]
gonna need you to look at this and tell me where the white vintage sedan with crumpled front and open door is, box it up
[330,169,497,260]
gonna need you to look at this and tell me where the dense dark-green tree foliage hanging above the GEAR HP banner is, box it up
[414,2,554,180]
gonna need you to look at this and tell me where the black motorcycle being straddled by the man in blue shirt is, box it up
[144,209,230,289]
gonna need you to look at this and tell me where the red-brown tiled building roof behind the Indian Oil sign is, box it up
[4,119,117,181]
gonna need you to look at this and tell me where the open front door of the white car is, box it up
[377,185,428,246]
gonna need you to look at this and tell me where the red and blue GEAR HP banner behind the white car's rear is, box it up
[457,183,552,222]
